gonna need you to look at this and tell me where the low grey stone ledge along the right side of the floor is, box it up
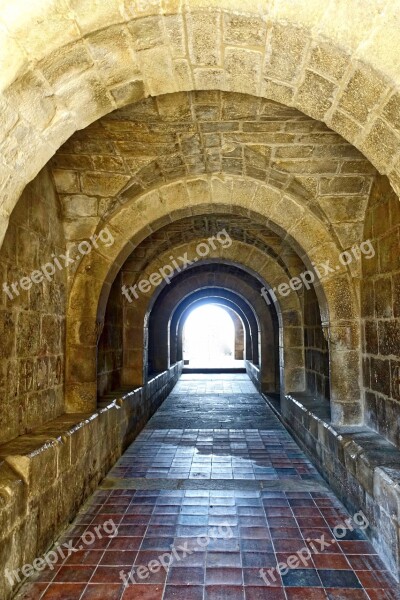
[266,395,400,580]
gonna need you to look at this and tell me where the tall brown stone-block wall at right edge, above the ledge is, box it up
[362,173,400,446]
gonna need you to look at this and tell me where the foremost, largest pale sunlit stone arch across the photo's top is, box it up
[0,0,400,246]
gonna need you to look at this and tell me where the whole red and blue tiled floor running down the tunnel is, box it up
[18,375,400,600]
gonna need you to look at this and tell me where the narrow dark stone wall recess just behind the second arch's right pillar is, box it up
[304,288,330,399]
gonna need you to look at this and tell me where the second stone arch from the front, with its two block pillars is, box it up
[66,176,361,423]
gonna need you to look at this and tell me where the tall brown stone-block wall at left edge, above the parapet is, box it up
[0,169,67,443]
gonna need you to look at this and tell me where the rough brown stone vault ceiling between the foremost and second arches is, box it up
[52,91,376,247]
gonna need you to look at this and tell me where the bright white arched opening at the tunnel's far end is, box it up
[183,303,245,370]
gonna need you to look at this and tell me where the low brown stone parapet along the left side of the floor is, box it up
[0,363,183,600]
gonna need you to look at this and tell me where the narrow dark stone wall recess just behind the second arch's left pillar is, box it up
[97,274,123,397]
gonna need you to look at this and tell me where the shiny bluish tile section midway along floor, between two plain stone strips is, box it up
[110,429,319,481]
